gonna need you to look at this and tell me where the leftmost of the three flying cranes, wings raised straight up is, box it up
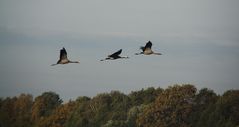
[51,47,79,66]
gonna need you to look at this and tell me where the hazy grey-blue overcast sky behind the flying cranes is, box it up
[0,0,239,100]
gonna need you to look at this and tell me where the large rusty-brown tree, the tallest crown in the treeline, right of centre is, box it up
[137,85,196,127]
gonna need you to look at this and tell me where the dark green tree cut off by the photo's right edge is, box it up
[192,90,239,127]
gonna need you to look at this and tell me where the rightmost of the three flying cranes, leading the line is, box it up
[135,41,162,55]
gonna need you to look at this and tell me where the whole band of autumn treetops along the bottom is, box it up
[0,84,239,127]
